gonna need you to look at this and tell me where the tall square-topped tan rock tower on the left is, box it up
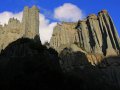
[22,6,39,39]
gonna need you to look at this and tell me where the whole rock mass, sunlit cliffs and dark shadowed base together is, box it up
[0,6,120,90]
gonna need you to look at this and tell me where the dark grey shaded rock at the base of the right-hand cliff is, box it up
[60,48,120,90]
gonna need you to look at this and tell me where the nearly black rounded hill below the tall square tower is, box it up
[0,38,82,90]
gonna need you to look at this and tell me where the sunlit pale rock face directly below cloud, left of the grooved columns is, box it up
[50,22,79,52]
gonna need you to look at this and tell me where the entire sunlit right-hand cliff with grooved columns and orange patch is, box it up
[50,10,120,63]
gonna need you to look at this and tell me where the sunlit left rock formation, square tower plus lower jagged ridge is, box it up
[0,6,40,51]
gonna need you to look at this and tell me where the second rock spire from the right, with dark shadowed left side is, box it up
[87,14,102,54]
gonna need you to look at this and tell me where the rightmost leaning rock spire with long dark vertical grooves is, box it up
[98,10,120,56]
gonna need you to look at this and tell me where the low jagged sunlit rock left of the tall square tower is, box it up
[0,18,23,50]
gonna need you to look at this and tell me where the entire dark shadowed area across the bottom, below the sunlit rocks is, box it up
[0,38,120,90]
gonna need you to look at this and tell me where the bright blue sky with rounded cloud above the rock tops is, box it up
[0,0,120,42]
